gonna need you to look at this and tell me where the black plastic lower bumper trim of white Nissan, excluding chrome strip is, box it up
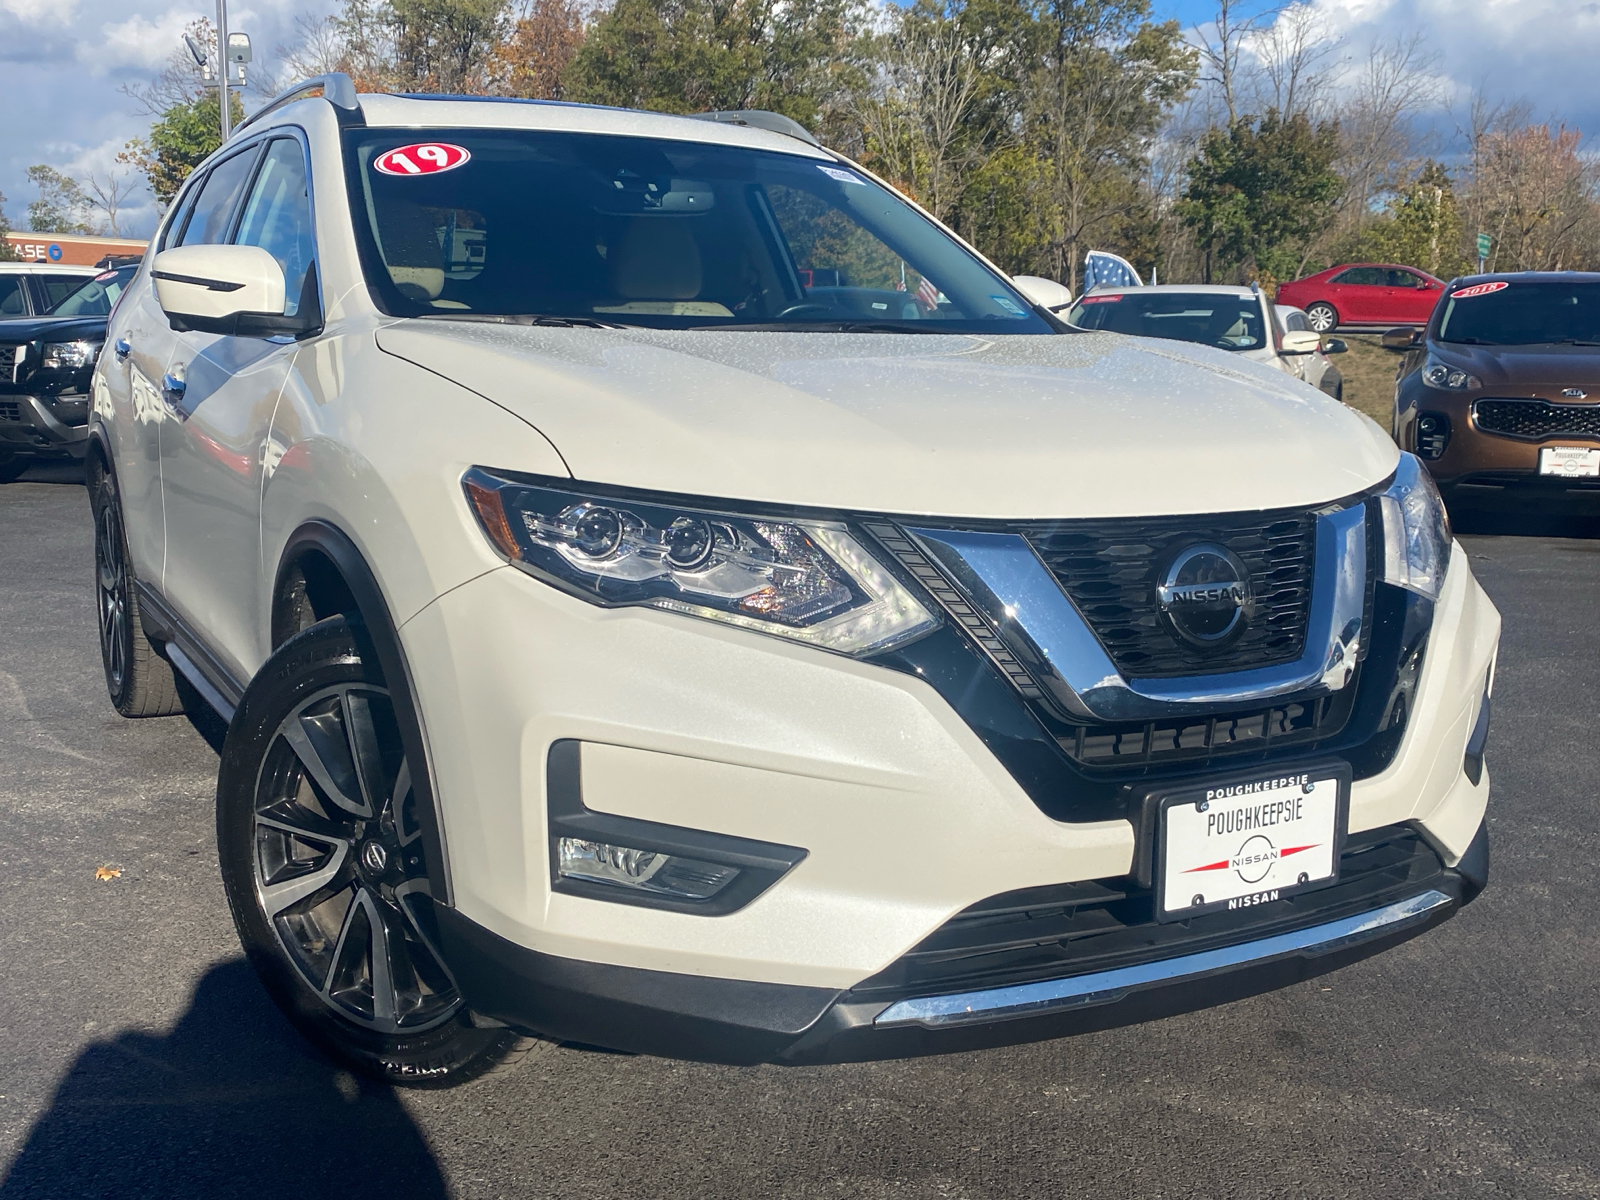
[435,827,1488,1066]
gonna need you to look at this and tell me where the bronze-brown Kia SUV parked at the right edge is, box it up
[1394,270,1600,506]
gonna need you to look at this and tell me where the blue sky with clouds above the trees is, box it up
[0,0,1600,235]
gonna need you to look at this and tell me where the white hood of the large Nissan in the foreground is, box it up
[378,318,1398,518]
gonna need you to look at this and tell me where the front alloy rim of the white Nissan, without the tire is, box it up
[253,683,462,1035]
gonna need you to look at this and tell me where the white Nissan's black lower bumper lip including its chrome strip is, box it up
[440,826,1490,1066]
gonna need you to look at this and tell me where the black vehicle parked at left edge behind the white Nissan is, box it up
[0,264,139,483]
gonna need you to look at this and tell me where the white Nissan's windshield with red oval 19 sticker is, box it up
[346,130,1053,333]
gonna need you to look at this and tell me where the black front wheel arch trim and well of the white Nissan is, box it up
[270,520,454,904]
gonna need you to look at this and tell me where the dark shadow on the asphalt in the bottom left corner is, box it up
[0,960,448,1200]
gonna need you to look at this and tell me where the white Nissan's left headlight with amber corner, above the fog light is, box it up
[462,467,938,654]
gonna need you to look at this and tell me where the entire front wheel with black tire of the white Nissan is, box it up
[216,616,538,1088]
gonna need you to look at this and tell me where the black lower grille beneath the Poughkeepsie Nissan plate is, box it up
[851,826,1458,1000]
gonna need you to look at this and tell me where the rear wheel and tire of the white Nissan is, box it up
[90,470,184,717]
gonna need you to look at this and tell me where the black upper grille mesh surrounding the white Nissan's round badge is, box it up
[1011,509,1317,678]
